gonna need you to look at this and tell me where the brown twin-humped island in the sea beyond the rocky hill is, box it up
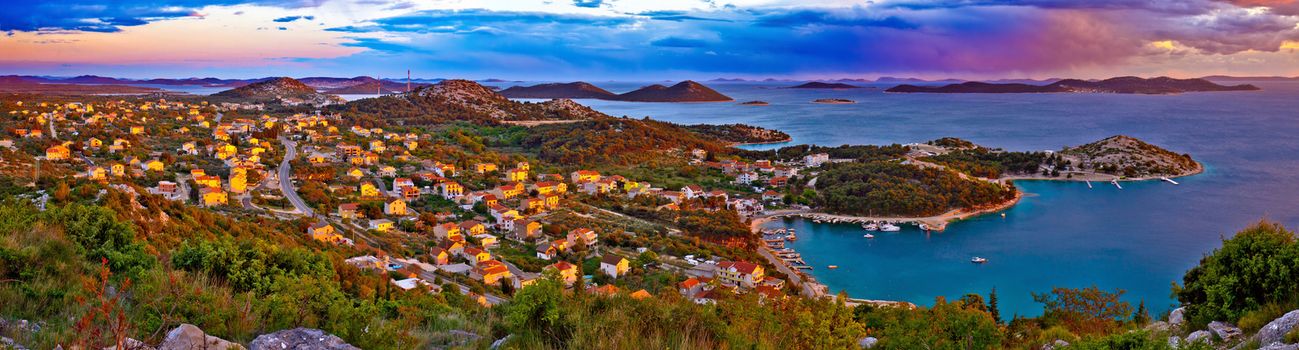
[500,81,734,101]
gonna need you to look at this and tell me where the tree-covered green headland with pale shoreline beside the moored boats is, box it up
[816,161,1015,216]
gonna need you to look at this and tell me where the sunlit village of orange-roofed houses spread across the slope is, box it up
[0,95,830,306]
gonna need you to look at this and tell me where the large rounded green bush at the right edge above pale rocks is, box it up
[1174,222,1299,329]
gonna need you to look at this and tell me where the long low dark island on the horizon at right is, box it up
[885,77,1259,94]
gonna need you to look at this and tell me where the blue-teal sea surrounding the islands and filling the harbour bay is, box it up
[548,82,1299,316]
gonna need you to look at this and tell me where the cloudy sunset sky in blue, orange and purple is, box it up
[0,0,1299,81]
